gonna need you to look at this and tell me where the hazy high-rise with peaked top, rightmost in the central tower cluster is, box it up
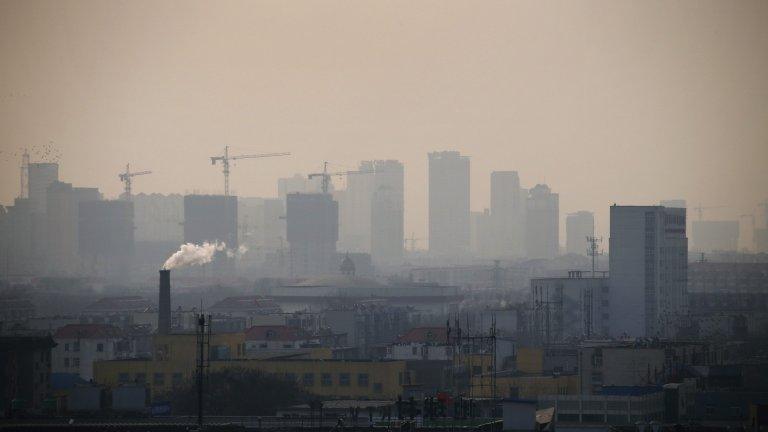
[525,184,560,259]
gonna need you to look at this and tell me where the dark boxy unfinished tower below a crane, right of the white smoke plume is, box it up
[286,193,339,277]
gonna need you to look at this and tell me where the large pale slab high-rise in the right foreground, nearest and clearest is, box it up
[609,205,688,337]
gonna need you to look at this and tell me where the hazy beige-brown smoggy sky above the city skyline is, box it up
[0,0,768,248]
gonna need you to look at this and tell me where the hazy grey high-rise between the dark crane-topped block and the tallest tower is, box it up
[370,160,405,266]
